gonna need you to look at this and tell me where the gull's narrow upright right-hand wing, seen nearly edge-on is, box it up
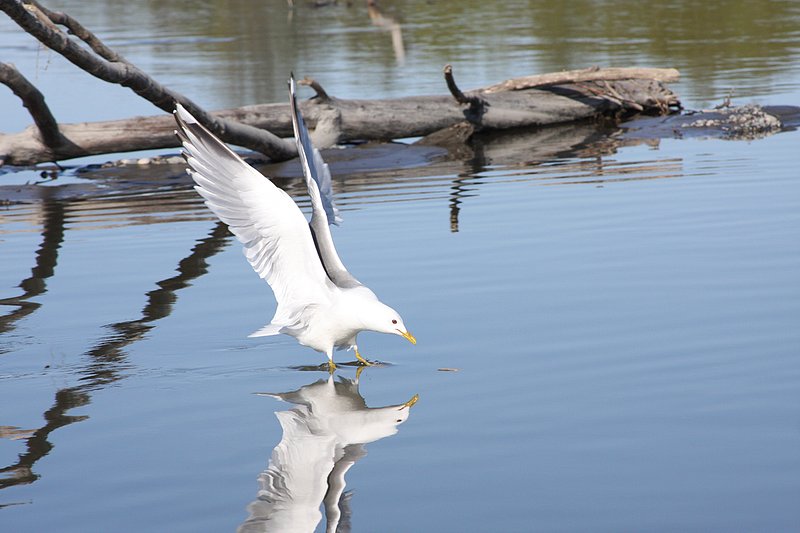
[289,77,361,288]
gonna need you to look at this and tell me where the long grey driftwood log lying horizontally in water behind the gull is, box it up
[0,69,679,165]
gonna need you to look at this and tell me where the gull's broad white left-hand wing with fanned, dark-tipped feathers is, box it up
[175,104,333,325]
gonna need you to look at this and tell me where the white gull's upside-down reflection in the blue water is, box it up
[239,376,418,533]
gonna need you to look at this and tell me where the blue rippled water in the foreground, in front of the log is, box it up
[0,1,800,532]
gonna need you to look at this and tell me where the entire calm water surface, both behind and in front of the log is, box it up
[0,1,800,532]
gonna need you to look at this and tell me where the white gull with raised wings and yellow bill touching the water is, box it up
[175,77,417,372]
